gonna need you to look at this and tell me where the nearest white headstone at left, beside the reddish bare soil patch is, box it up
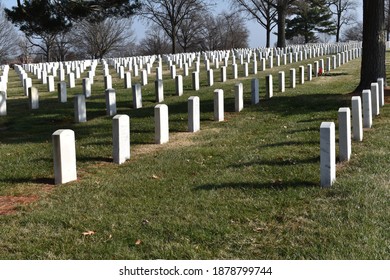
[52,129,77,185]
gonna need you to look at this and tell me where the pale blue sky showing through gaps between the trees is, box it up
[0,0,362,48]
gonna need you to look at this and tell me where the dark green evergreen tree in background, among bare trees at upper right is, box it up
[286,0,336,43]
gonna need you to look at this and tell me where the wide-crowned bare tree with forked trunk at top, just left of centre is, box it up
[140,0,206,53]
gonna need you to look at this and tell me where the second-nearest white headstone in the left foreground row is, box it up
[112,115,130,164]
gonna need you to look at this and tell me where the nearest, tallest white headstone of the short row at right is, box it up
[320,122,336,187]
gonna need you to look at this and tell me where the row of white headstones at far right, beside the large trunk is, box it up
[320,78,385,187]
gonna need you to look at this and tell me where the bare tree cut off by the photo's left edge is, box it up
[0,4,19,63]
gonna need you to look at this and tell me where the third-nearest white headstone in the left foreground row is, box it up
[154,104,169,144]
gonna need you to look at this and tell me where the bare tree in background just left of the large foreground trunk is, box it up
[329,0,357,42]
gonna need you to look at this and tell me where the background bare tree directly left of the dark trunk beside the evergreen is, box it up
[230,0,277,48]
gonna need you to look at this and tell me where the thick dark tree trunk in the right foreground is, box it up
[357,0,386,91]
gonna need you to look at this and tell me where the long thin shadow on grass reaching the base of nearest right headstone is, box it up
[194,180,319,191]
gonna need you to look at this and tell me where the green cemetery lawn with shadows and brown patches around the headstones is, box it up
[0,51,390,259]
